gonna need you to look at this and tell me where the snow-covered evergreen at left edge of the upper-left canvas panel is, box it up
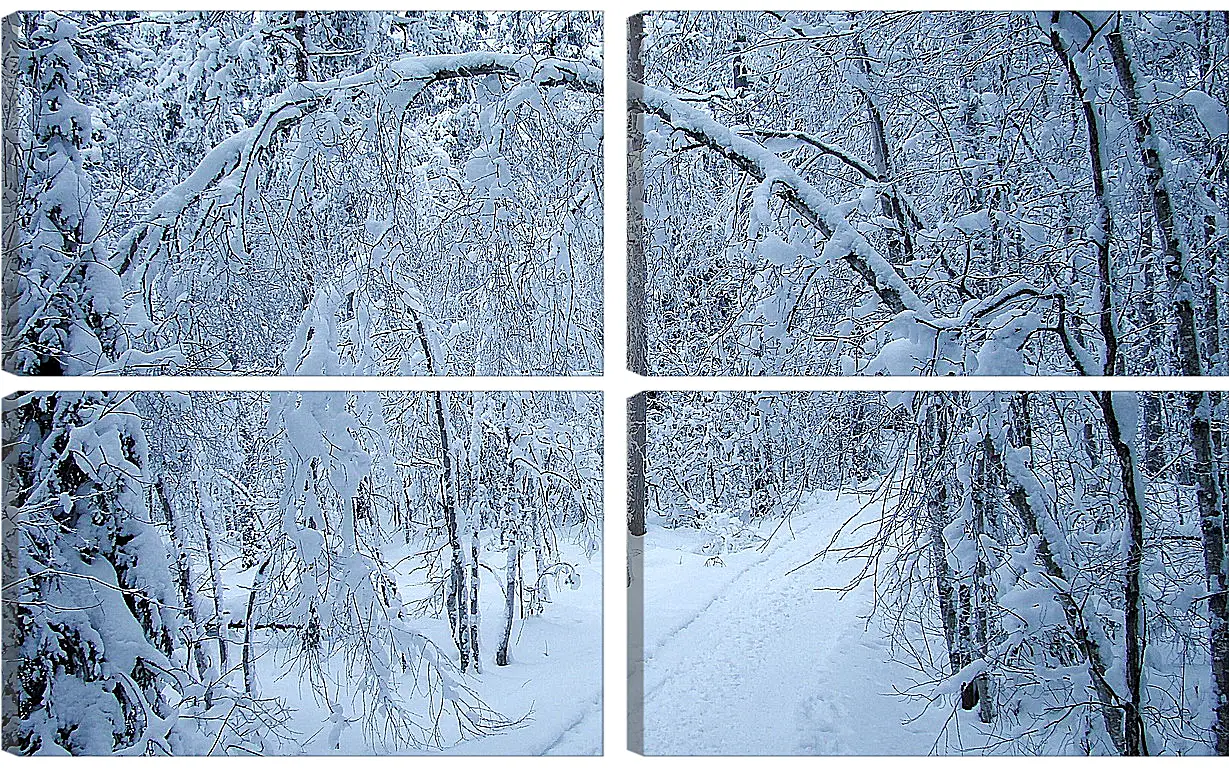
[4,12,127,375]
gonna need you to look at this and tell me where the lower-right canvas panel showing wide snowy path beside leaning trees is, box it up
[629,392,1229,754]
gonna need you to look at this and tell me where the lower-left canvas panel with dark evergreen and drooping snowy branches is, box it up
[2,392,602,754]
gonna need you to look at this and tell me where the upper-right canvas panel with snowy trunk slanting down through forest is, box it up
[628,11,1229,376]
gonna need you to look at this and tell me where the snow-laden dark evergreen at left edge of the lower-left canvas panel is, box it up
[4,393,179,754]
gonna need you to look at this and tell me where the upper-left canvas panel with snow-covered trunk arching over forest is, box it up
[0,11,602,376]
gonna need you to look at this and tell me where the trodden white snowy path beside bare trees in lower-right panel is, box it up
[644,495,941,754]
